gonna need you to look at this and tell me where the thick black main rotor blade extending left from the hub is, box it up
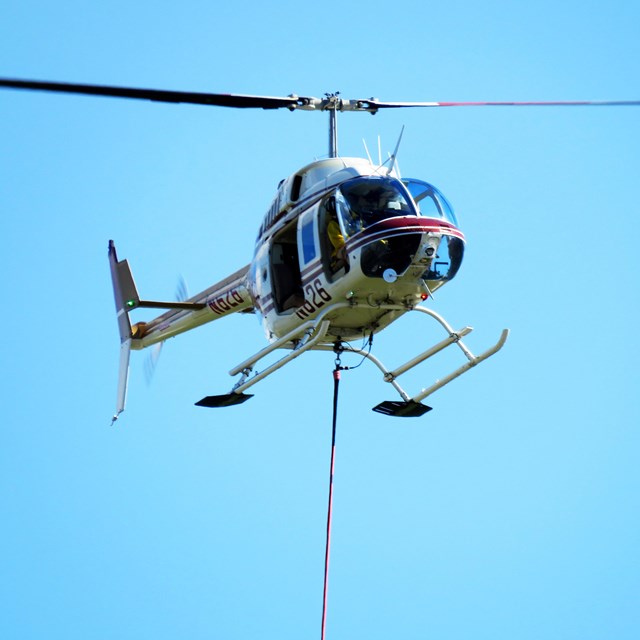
[0,78,299,109]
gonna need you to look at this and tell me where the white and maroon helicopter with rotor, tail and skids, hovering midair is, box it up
[0,78,640,423]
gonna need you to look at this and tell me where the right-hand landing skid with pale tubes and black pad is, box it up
[313,304,509,418]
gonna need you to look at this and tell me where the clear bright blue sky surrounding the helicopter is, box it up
[0,0,640,640]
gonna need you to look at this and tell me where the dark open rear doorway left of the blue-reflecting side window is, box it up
[269,220,304,313]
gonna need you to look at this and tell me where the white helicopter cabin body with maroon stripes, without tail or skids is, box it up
[247,158,464,342]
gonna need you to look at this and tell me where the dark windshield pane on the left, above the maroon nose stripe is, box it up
[336,177,416,236]
